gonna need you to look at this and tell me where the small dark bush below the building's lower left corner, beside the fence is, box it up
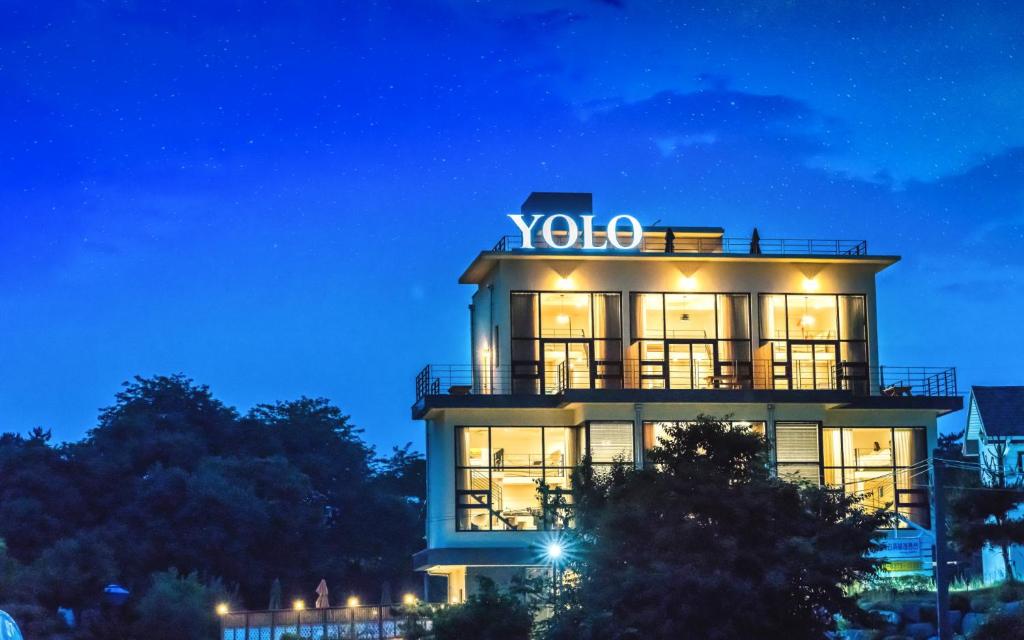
[432,577,534,640]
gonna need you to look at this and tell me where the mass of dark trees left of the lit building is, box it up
[0,376,425,637]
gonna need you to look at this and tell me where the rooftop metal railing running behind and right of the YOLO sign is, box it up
[493,233,867,256]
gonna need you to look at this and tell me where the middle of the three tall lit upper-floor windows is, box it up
[630,293,753,389]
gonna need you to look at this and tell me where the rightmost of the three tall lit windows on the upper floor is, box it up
[760,294,868,393]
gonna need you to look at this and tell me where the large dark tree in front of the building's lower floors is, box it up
[548,417,890,640]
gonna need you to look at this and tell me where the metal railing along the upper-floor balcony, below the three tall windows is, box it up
[416,359,958,401]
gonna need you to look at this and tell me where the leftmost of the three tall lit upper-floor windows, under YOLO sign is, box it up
[511,292,623,393]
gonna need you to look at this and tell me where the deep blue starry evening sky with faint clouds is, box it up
[0,0,1024,450]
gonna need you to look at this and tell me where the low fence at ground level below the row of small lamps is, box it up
[220,605,430,640]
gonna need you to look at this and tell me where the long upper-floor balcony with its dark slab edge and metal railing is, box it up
[413,360,963,418]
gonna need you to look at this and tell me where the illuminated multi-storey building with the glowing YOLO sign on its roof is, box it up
[413,194,963,601]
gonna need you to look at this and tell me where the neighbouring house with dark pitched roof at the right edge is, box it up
[964,380,1024,583]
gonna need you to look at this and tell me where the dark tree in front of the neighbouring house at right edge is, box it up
[949,436,1024,582]
